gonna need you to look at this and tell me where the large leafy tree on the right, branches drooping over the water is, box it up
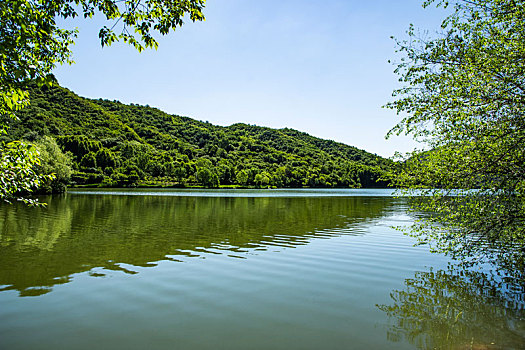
[387,0,525,278]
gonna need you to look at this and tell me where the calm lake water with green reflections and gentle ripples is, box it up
[0,190,525,349]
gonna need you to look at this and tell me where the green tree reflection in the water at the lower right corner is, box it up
[378,267,525,349]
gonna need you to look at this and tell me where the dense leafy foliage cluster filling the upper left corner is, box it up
[0,0,75,120]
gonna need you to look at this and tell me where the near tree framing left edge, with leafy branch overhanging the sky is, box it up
[0,0,205,199]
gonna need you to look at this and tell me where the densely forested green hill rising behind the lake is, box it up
[3,78,392,189]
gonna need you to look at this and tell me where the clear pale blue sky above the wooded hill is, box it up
[54,0,443,156]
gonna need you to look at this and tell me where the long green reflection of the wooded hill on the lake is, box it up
[0,194,392,295]
